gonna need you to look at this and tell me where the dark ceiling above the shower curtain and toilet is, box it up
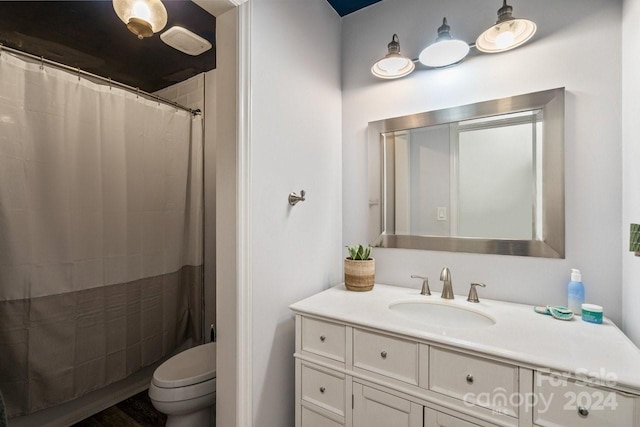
[0,0,216,92]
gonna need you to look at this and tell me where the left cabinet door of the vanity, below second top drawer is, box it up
[353,383,422,427]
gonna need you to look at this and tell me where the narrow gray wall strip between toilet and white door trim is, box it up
[216,8,238,426]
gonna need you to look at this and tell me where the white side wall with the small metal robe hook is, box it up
[248,0,342,427]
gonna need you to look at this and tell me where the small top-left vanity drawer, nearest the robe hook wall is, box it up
[302,317,345,363]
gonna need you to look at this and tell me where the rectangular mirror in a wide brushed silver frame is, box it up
[368,88,565,258]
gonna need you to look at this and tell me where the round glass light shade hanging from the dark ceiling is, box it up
[113,0,167,40]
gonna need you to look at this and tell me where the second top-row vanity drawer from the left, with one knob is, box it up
[353,329,418,385]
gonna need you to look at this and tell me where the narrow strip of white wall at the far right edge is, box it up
[622,0,640,346]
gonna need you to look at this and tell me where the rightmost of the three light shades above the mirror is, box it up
[476,0,537,53]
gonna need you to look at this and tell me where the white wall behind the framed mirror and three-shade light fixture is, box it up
[342,0,624,324]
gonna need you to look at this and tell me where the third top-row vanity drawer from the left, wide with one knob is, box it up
[429,347,518,417]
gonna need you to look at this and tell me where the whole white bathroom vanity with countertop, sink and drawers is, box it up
[290,284,640,427]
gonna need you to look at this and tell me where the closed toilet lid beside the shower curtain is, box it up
[152,342,216,388]
